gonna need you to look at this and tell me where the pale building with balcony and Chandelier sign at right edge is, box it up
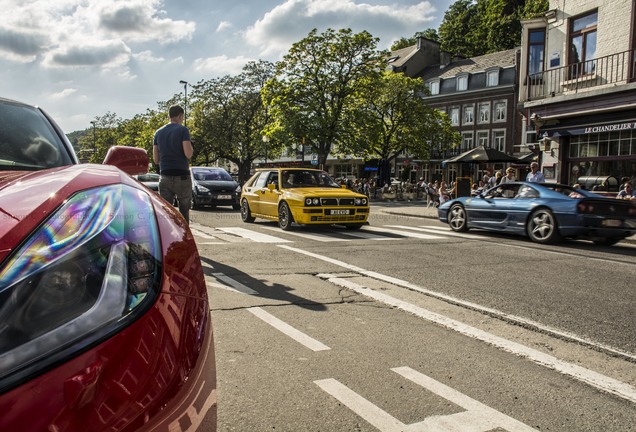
[519,0,636,188]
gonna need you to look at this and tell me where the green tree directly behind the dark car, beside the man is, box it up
[190,61,277,182]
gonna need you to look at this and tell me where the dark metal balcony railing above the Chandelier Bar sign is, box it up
[526,50,636,101]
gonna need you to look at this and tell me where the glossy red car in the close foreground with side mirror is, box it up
[0,99,216,432]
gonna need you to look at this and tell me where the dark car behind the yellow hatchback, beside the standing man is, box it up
[190,167,241,210]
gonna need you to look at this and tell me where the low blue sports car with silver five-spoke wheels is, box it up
[438,182,636,245]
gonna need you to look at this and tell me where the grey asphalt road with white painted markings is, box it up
[191,203,636,431]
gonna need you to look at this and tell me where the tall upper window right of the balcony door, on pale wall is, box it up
[568,12,598,78]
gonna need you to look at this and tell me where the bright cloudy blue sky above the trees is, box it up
[0,0,454,133]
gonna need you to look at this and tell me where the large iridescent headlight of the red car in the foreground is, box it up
[0,184,161,378]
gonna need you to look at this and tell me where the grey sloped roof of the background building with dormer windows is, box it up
[420,48,517,81]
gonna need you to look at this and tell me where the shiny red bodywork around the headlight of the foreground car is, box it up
[0,160,217,432]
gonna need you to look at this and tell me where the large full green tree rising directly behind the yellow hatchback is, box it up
[263,29,388,170]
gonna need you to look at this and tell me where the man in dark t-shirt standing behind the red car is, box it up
[152,105,194,223]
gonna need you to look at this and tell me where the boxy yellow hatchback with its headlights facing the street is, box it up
[241,168,369,230]
